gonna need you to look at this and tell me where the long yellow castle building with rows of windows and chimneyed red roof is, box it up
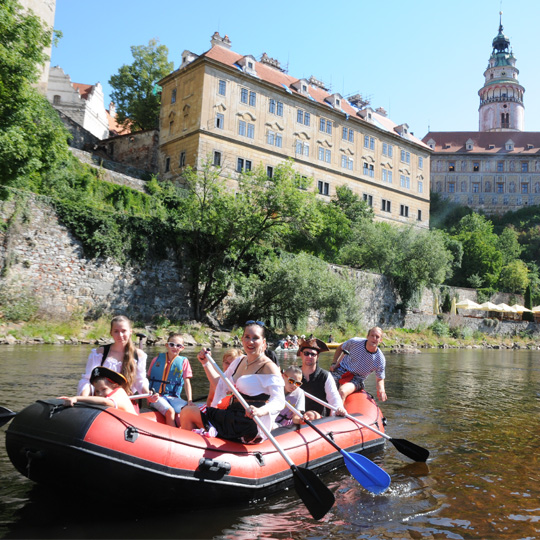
[159,32,431,228]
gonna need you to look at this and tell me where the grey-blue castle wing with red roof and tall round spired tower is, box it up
[422,13,540,214]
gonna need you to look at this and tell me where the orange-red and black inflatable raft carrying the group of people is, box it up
[6,392,385,503]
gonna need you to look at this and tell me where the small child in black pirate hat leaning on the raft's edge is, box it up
[58,366,137,414]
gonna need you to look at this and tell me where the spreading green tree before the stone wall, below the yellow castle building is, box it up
[168,162,315,320]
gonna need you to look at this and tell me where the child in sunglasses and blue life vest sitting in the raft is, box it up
[148,332,193,427]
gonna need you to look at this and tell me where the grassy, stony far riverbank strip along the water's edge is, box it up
[0,318,540,354]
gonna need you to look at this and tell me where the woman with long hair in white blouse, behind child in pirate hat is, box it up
[77,315,148,396]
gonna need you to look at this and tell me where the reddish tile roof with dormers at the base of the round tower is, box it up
[422,131,540,155]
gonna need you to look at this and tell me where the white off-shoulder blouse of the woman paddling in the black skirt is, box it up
[212,356,285,439]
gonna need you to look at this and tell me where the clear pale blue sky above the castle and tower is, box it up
[51,0,540,137]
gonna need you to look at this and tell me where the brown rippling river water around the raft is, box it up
[0,346,540,540]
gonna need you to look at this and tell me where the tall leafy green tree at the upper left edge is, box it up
[0,0,69,183]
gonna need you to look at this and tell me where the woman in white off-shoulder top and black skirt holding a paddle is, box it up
[180,321,285,443]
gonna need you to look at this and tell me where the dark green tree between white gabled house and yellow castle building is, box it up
[109,39,174,131]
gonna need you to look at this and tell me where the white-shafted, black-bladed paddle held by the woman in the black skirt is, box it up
[206,352,335,519]
